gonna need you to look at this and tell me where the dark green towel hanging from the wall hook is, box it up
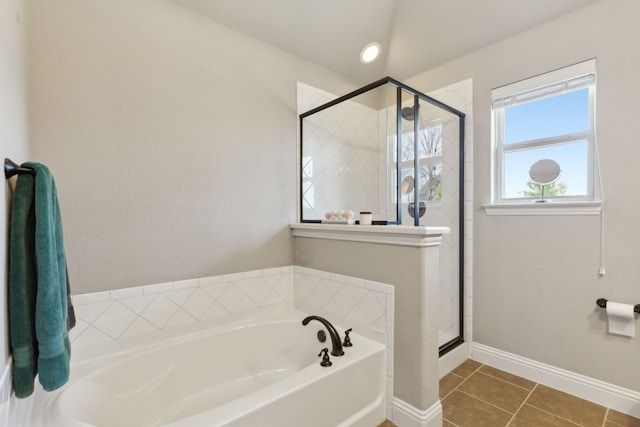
[9,162,71,398]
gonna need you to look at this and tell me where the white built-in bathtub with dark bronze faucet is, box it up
[28,309,386,427]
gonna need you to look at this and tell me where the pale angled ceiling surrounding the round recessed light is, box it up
[170,0,601,84]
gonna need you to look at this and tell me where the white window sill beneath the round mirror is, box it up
[482,201,602,215]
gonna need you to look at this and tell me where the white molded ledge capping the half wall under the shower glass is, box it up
[290,223,450,247]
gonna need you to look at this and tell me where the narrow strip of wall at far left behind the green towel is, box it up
[0,0,29,368]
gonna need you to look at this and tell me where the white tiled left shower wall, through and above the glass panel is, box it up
[298,83,382,219]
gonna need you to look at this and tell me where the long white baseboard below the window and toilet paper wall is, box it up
[471,343,640,418]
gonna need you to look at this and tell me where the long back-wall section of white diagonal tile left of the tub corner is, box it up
[70,266,294,348]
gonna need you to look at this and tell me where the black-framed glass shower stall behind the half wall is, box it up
[299,77,465,355]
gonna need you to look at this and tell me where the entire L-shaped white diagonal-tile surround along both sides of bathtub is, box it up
[65,266,394,418]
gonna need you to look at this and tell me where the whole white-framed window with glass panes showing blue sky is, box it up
[491,59,596,203]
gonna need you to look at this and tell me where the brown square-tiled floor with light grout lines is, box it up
[440,360,640,427]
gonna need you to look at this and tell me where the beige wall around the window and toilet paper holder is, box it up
[407,0,640,391]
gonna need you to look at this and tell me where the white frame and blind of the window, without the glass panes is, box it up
[491,59,596,205]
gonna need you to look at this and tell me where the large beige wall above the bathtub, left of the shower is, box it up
[27,0,356,294]
